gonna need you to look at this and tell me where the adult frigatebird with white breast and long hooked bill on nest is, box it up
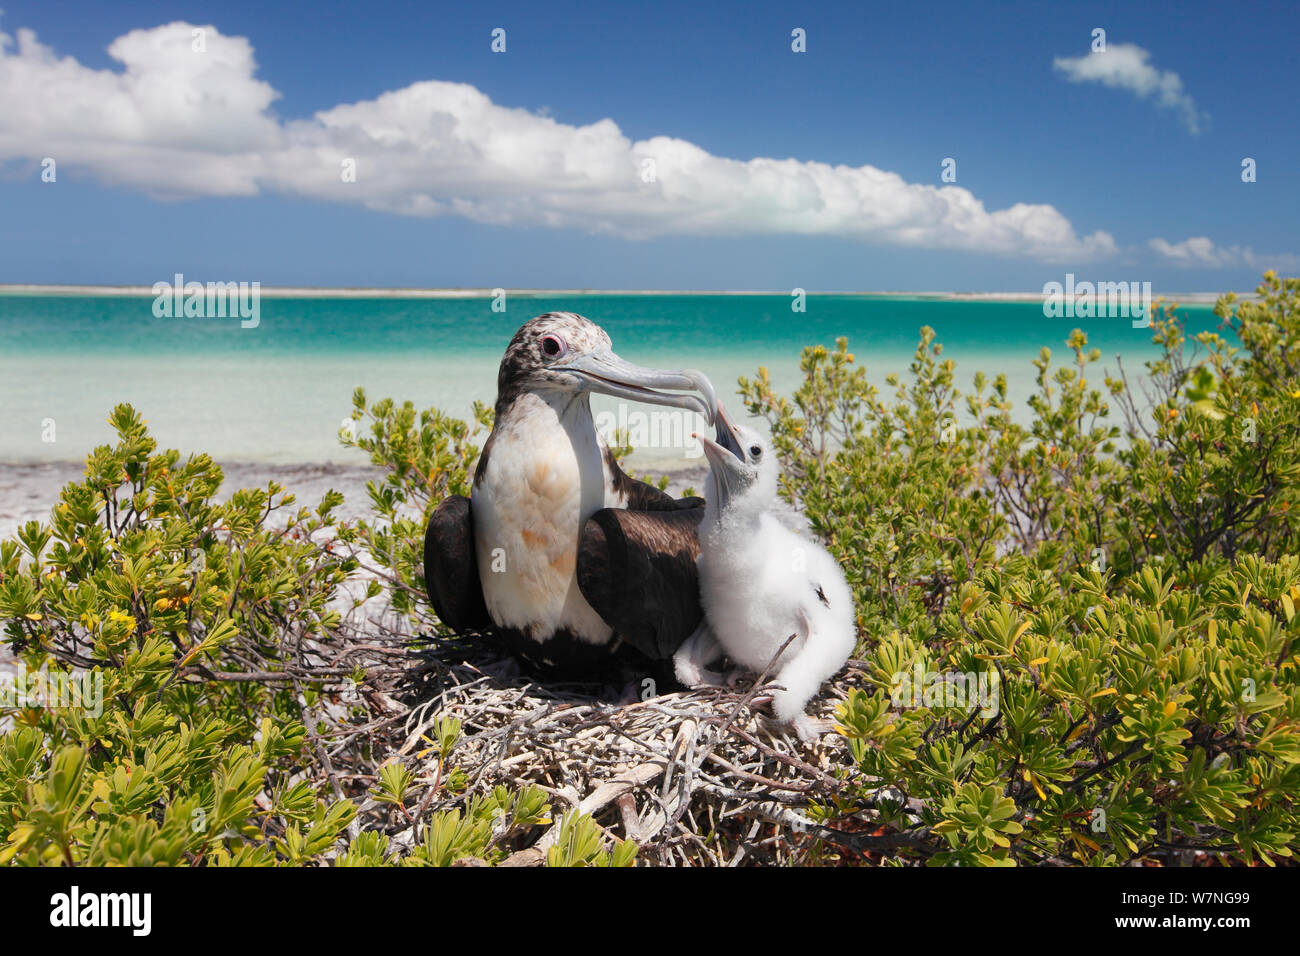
[424,312,722,670]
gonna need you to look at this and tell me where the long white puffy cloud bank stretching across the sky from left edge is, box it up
[0,22,1115,261]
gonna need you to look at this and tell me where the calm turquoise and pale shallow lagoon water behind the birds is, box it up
[0,294,1217,466]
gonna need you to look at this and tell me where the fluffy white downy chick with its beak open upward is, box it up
[673,403,857,740]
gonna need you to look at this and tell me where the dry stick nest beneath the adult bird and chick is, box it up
[311,635,857,866]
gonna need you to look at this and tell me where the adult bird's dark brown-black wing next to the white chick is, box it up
[577,504,705,661]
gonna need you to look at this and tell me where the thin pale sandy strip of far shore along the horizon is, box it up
[0,282,1242,306]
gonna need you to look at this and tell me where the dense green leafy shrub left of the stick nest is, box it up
[0,406,355,865]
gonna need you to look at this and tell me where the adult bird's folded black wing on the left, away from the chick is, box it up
[424,494,491,633]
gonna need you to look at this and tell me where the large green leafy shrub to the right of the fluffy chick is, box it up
[741,273,1300,865]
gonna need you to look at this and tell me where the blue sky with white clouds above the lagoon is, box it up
[0,0,1300,291]
